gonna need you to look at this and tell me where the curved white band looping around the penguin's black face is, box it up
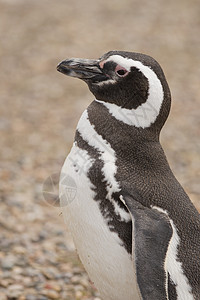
[96,55,164,128]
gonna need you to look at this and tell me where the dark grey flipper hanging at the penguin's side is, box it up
[121,195,173,300]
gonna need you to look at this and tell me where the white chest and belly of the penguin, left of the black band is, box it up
[60,145,140,300]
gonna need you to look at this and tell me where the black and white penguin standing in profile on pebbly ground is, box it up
[57,51,200,300]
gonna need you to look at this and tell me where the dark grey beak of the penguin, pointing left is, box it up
[57,58,108,82]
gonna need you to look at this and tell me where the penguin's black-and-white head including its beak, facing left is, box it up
[57,51,171,129]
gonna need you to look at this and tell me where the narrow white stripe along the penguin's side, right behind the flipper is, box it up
[152,206,194,300]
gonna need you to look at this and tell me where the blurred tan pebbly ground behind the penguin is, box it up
[0,0,200,300]
